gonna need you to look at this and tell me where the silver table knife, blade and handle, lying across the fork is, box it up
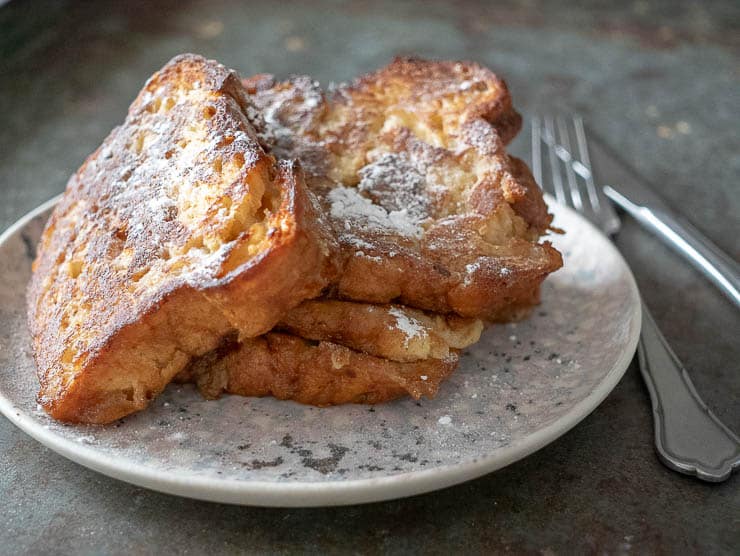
[573,129,740,309]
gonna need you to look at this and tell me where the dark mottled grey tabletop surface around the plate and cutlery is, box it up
[0,0,740,554]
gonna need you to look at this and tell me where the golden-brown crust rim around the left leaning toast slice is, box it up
[27,55,333,423]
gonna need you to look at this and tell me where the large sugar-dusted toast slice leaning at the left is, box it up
[28,55,331,423]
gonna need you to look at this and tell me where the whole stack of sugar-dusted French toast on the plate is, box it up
[28,54,562,423]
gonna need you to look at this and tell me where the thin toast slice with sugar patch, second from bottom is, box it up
[276,299,483,362]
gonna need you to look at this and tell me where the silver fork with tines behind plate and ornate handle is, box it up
[532,116,740,482]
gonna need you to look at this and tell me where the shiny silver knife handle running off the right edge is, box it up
[604,185,740,309]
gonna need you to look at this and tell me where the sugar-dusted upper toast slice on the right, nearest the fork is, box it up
[244,59,562,320]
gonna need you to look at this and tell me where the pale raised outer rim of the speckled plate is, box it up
[0,194,642,507]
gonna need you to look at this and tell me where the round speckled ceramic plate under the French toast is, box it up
[0,197,640,506]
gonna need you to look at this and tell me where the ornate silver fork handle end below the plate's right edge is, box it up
[637,303,740,482]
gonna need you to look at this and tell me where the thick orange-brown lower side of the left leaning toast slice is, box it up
[29,164,336,423]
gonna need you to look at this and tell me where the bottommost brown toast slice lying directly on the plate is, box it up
[175,332,458,406]
